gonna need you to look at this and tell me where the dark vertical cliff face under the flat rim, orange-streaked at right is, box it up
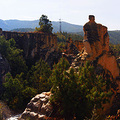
[2,31,57,58]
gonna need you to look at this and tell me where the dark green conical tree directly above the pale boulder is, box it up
[27,59,51,93]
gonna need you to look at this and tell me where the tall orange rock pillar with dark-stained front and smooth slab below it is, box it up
[80,15,120,79]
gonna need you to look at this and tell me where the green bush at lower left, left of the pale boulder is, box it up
[2,73,37,110]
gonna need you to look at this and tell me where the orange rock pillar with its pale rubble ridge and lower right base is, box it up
[68,15,120,114]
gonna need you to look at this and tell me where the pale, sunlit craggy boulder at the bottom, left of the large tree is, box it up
[19,92,53,120]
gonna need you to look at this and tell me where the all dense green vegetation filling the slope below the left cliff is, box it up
[0,36,51,109]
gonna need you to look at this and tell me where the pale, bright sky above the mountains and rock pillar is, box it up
[0,0,120,30]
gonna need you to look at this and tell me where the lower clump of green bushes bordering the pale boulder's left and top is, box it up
[2,60,51,110]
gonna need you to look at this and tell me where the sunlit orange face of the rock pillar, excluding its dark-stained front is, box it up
[81,23,120,79]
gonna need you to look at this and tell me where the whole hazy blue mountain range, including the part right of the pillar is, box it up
[0,19,120,44]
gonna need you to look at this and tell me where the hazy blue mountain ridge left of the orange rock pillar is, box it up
[0,20,83,32]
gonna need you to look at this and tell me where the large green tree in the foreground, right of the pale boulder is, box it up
[50,59,111,120]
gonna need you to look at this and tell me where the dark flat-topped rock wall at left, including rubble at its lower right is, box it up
[0,29,62,67]
